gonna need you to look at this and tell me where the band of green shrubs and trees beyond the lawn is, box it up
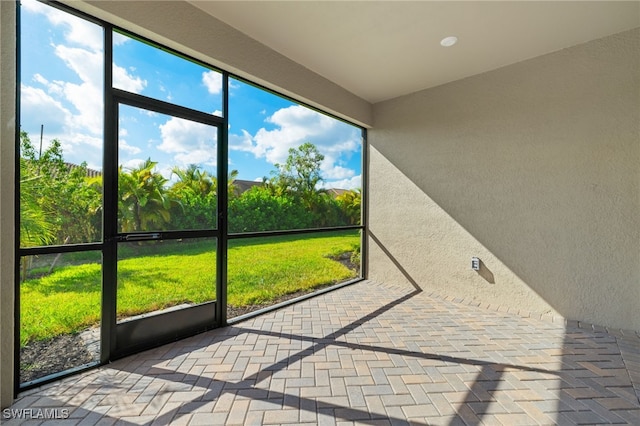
[20,136,361,241]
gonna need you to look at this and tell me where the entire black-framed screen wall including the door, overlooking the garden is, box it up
[16,1,364,392]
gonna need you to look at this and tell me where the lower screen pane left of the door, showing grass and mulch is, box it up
[20,251,102,383]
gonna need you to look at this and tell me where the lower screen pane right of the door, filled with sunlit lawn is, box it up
[227,231,360,318]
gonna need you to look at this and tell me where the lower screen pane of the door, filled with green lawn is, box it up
[117,238,217,321]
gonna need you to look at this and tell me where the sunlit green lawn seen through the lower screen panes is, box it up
[20,231,360,345]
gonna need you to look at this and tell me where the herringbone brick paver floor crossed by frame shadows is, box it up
[3,281,640,425]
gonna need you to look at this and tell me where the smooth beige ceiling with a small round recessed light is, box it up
[189,0,640,103]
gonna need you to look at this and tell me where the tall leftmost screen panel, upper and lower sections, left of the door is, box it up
[16,1,104,383]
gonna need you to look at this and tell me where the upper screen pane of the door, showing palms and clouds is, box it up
[118,105,218,232]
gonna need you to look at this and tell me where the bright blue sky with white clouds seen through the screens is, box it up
[20,0,361,189]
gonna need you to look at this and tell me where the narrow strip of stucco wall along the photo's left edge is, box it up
[0,1,16,408]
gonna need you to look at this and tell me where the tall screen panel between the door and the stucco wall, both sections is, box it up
[227,79,363,318]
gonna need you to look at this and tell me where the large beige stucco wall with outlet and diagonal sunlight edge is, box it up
[369,29,640,330]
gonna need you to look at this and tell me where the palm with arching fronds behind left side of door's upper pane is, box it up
[118,158,178,232]
